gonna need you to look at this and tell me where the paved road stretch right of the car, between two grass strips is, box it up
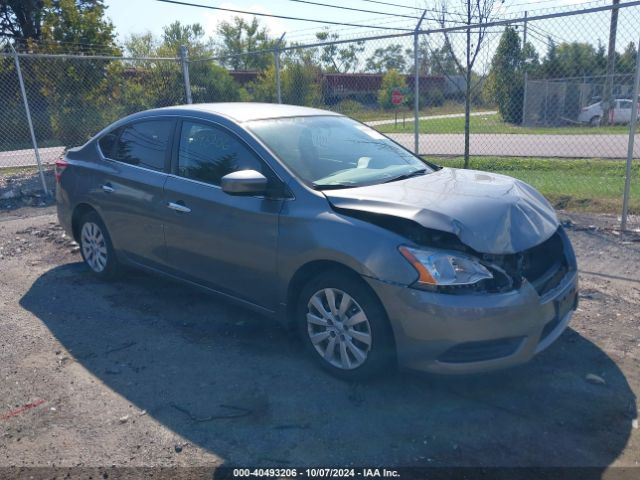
[389,133,640,158]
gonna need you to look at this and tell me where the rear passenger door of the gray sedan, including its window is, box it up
[97,117,175,266]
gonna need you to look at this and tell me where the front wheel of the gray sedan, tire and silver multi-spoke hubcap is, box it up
[296,269,395,380]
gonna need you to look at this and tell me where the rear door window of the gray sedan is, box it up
[113,120,173,171]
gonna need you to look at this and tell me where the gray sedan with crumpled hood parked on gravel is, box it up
[56,103,577,379]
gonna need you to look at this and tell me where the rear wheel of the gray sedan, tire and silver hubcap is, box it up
[78,212,120,280]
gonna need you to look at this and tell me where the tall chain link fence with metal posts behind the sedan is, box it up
[0,2,640,229]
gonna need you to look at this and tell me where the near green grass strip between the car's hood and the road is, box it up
[427,157,640,214]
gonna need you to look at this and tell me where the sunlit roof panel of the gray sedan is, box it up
[156,102,340,122]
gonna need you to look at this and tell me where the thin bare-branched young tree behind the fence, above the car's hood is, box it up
[440,0,495,168]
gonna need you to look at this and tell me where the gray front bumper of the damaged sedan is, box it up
[366,270,578,374]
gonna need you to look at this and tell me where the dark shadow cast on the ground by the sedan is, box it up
[20,263,636,467]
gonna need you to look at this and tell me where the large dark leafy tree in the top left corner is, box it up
[0,0,119,148]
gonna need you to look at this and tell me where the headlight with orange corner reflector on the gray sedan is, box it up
[399,247,493,286]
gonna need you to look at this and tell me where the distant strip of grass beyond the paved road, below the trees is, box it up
[374,112,629,135]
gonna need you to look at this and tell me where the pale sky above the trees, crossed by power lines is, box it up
[105,0,640,72]
